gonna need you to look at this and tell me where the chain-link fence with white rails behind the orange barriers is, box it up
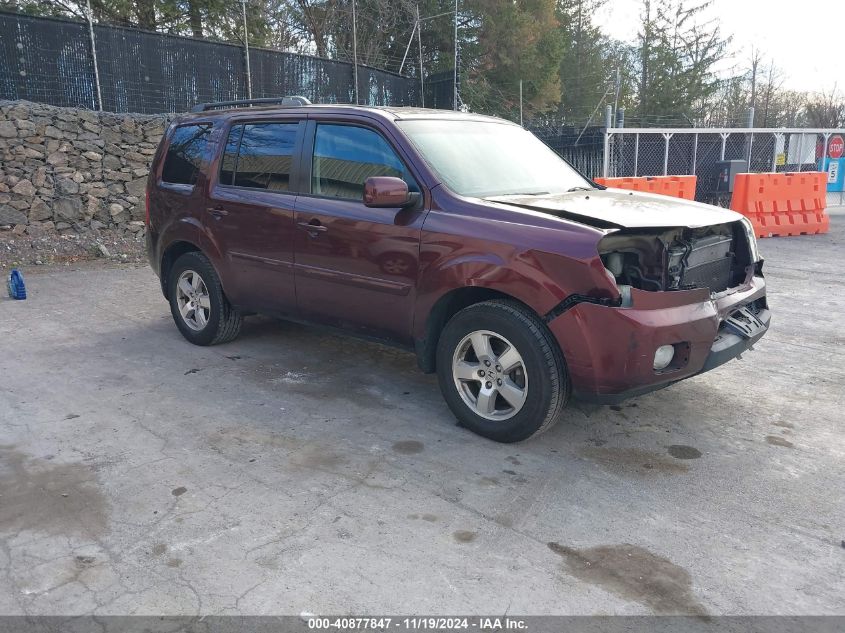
[604,128,845,206]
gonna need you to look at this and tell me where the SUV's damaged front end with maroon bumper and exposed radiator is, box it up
[549,219,770,404]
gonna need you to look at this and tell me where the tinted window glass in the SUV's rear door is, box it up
[220,123,299,191]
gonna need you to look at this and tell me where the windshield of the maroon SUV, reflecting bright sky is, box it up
[397,119,591,198]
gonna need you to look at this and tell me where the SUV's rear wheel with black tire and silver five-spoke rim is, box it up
[167,252,243,345]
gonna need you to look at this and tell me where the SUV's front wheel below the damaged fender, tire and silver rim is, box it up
[437,299,570,443]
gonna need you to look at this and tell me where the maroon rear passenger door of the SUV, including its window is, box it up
[204,118,305,315]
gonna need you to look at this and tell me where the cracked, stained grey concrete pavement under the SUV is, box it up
[0,216,845,615]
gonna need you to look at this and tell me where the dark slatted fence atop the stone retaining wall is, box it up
[0,12,420,114]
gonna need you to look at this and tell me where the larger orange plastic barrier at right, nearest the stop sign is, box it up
[731,171,830,237]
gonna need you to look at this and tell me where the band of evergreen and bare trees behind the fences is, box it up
[0,0,845,127]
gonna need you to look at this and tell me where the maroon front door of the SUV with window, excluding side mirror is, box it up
[296,121,425,343]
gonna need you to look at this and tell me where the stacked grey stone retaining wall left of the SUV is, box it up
[0,101,170,234]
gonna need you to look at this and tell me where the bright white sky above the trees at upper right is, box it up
[595,0,845,93]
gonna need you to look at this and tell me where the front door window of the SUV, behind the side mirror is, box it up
[311,124,419,200]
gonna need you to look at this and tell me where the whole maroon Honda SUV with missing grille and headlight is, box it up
[147,97,770,442]
